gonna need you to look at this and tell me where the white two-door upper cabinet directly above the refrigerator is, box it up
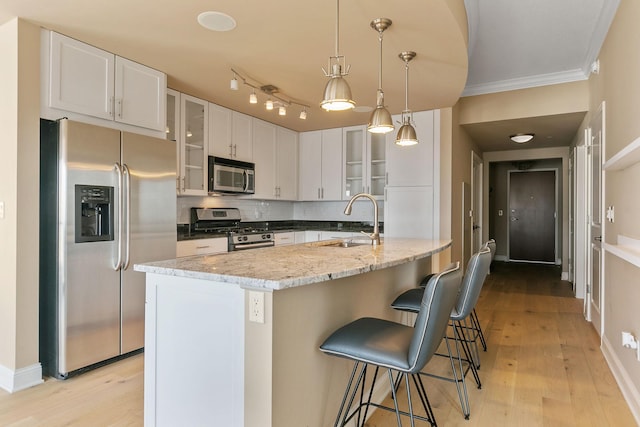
[47,32,167,131]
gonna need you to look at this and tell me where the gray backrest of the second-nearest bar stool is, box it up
[451,246,491,320]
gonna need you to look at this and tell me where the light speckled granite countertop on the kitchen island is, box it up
[134,238,451,290]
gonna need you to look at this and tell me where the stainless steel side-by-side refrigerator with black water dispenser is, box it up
[40,119,176,378]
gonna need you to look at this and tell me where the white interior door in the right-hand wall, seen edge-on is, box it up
[587,102,604,335]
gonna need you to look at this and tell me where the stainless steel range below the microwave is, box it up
[191,208,275,252]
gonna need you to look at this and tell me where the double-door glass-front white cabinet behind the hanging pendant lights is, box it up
[342,126,385,200]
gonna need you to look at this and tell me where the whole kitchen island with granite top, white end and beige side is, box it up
[135,238,451,427]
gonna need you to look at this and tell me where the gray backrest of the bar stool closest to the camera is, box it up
[408,262,462,374]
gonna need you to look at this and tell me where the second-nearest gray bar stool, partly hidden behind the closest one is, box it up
[391,246,491,419]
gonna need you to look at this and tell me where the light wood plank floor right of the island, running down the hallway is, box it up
[367,262,636,427]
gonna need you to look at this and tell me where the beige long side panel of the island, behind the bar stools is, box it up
[268,257,432,427]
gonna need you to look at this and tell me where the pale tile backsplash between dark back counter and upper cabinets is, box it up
[177,196,384,224]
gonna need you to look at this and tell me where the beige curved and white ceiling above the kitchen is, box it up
[0,0,619,150]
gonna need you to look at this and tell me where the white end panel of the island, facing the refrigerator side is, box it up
[144,273,244,427]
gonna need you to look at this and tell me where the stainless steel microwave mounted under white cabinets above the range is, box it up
[209,156,255,194]
